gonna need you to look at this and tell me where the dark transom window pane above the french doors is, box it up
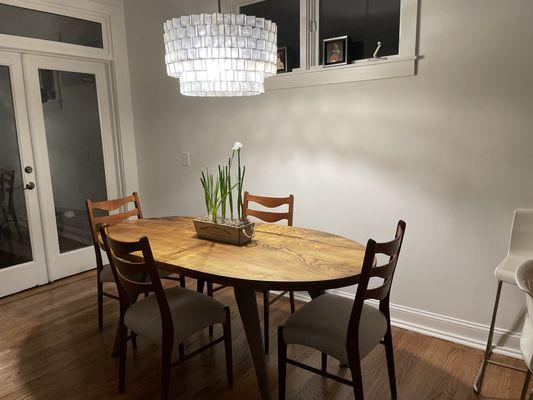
[0,4,104,48]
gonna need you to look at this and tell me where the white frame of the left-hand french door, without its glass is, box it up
[0,51,48,297]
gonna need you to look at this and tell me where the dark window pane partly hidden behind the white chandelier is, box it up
[240,0,300,71]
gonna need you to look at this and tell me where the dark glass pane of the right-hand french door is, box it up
[39,69,107,253]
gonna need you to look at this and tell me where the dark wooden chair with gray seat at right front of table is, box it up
[278,221,405,400]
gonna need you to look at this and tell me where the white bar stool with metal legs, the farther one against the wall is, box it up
[474,209,533,394]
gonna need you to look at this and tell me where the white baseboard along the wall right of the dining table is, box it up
[286,290,522,358]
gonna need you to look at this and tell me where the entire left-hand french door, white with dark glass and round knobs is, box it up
[0,52,48,297]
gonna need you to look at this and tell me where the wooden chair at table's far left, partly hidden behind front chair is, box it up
[85,192,185,331]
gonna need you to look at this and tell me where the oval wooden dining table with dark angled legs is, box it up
[109,217,365,400]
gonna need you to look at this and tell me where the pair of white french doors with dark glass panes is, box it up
[0,52,118,296]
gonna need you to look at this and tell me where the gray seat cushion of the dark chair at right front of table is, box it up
[283,294,387,364]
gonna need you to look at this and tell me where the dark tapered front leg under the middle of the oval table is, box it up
[234,287,270,400]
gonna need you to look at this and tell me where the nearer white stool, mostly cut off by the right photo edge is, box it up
[516,260,533,400]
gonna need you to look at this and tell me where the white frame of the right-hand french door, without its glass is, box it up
[22,54,120,281]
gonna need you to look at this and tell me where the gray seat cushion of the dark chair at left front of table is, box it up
[124,287,226,345]
